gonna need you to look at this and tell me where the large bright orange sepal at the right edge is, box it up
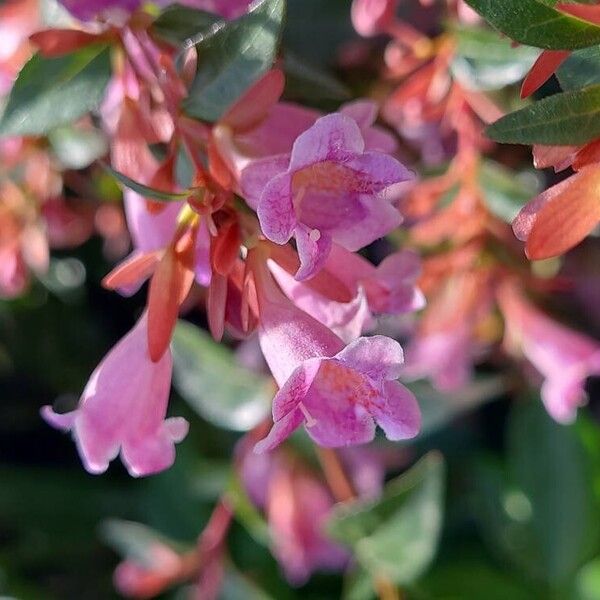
[525,167,600,260]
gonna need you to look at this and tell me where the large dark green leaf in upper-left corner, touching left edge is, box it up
[0,45,111,136]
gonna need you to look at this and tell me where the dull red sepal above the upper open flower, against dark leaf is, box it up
[222,69,285,131]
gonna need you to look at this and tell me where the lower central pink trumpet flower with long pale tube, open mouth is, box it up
[254,251,420,452]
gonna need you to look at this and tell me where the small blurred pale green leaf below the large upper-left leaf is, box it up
[48,126,108,169]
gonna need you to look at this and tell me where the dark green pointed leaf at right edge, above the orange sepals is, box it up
[486,85,600,146]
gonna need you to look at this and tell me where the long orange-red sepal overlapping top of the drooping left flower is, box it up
[148,231,196,362]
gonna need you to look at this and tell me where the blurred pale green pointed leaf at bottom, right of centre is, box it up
[329,453,444,585]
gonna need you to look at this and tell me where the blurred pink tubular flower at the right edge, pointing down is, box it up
[498,283,600,423]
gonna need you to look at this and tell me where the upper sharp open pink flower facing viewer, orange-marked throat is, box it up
[251,113,411,280]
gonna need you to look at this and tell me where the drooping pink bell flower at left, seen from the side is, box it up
[42,313,188,477]
